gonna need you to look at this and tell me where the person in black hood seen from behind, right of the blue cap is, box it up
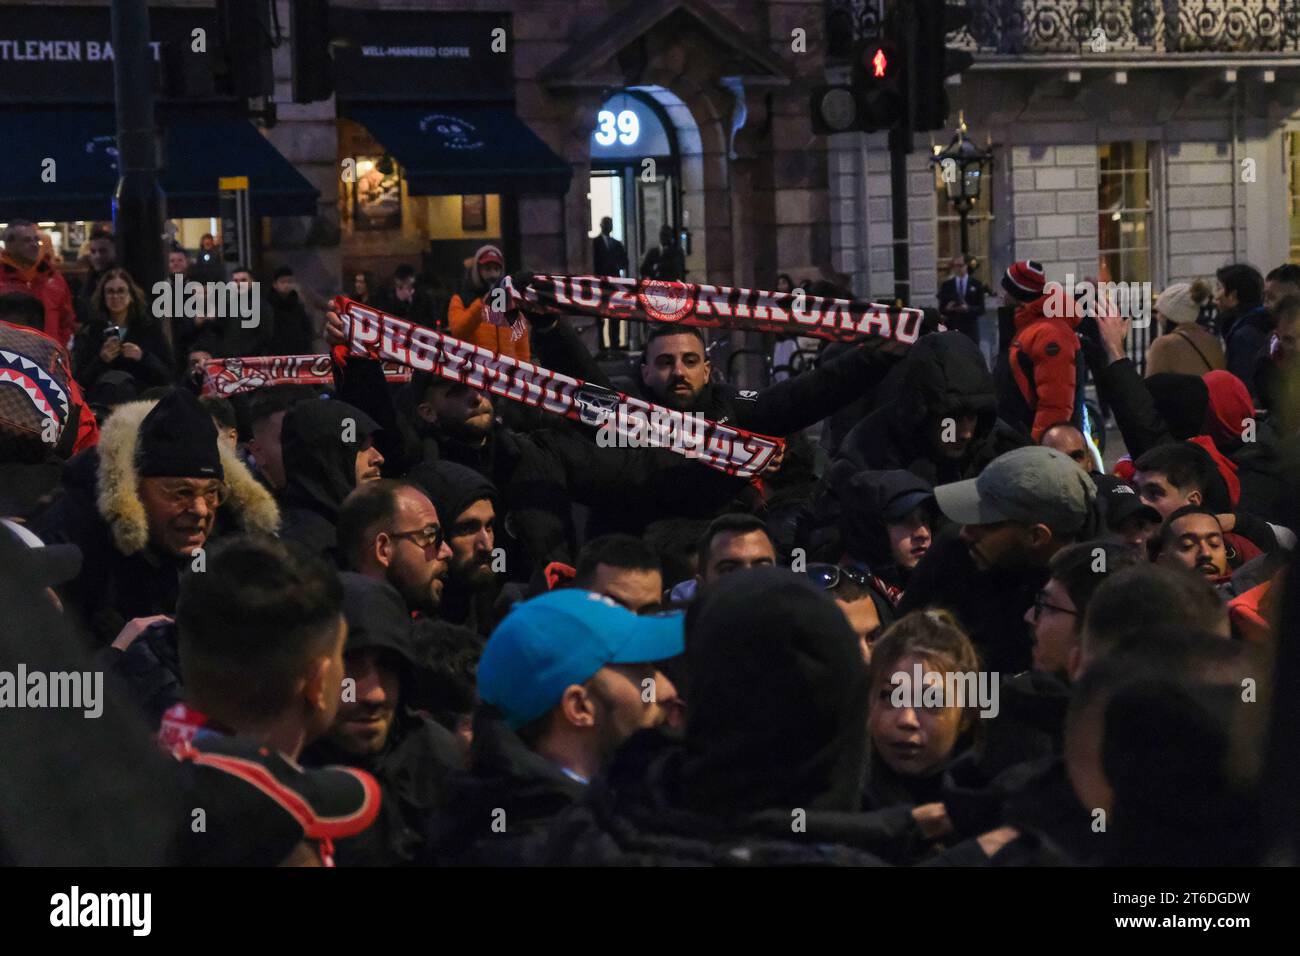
[545,568,1015,866]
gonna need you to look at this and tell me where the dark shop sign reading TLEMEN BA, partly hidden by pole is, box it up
[0,7,221,103]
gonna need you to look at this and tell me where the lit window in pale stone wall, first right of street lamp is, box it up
[1097,142,1152,282]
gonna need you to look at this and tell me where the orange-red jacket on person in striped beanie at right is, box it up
[1010,295,1082,441]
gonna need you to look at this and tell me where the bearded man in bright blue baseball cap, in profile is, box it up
[432,588,683,865]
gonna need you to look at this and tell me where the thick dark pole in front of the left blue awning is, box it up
[112,0,165,317]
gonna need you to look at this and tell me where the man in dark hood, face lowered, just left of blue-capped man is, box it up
[302,571,463,866]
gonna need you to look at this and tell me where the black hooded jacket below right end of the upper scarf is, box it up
[839,332,1031,485]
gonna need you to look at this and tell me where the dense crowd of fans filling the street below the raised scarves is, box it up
[0,224,1300,866]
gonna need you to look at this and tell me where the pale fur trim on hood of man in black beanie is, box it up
[95,402,280,554]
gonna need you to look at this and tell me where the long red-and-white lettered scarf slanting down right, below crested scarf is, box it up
[333,295,785,477]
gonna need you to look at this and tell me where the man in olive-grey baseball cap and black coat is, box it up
[898,445,1097,674]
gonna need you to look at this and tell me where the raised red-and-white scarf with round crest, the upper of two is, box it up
[485,276,924,345]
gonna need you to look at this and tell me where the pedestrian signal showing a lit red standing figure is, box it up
[813,42,907,134]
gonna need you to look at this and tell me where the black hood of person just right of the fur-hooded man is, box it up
[280,399,378,563]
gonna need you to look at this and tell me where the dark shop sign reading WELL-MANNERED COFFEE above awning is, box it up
[330,8,515,101]
